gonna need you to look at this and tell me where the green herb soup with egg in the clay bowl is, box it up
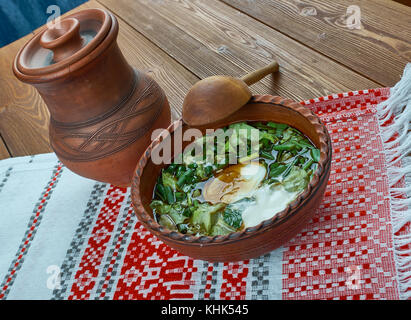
[151,122,320,236]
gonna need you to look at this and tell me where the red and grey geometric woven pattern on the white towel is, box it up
[0,89,406,300]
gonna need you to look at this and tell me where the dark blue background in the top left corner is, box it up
[0,0,86,48]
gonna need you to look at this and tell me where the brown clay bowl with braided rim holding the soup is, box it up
[131,95,332,262]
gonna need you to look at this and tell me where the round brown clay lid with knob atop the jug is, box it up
[13,9,118,82]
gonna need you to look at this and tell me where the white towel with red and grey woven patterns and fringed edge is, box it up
[0,67,411,299]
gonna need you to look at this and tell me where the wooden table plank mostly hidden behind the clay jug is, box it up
[0,1,198,157]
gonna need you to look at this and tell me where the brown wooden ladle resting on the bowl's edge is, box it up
[183,61,279,126]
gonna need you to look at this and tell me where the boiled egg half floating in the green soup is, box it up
[203,162,267,204]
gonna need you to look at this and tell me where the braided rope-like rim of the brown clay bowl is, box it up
[131,95,332,246]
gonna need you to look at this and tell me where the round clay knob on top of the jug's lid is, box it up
[40,18,83,62]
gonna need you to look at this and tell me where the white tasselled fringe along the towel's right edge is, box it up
[377,63,411,300]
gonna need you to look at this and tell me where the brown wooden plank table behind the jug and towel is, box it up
[0,0,411,159]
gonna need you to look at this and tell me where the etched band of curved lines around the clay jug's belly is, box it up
[50,72,166,162]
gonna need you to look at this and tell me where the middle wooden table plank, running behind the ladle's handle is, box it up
[99,0,380,101]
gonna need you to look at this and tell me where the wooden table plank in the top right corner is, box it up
[222,0,411,86]
